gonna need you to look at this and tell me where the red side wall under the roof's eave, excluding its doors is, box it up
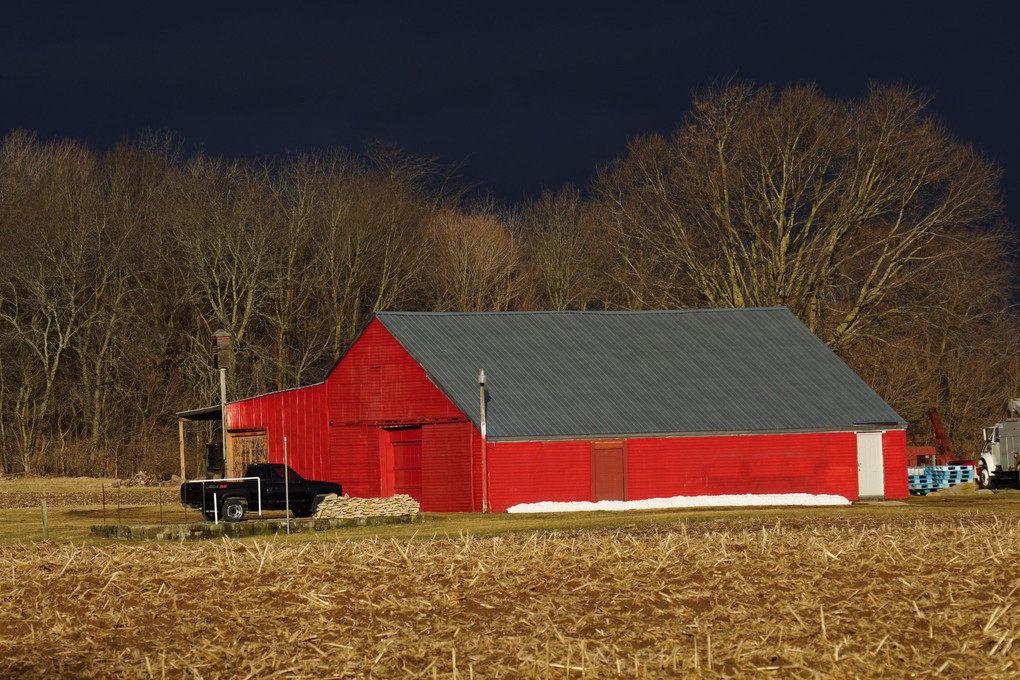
[489,430,907,512]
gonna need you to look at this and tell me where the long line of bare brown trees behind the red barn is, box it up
[0,86,1020,475]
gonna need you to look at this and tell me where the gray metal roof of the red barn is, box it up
[376,307,906,438]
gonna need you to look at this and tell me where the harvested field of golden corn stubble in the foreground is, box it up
[0,514,1020,678]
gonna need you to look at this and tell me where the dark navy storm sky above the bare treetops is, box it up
[0,1,1020,222]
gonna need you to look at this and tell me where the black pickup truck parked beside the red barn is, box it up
[181,463,344,522]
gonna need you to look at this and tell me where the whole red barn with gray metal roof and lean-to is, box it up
[215,308,908,512]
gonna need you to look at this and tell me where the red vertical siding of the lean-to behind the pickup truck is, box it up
[226,383,329,479]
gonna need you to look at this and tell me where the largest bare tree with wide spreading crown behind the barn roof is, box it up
[598,81,1002,350]
